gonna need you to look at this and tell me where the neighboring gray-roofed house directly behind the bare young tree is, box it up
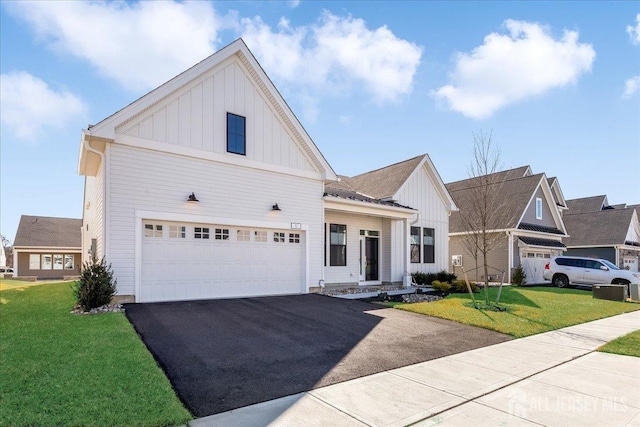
[446,166,567,283]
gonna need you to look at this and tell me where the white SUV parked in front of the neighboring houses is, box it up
[542,256,640,288]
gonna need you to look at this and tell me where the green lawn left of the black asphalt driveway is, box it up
[0,282,192,427]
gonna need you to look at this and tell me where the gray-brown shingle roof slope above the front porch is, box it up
[338,154,427,199]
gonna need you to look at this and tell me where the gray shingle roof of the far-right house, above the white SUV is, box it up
[563,208,633,247]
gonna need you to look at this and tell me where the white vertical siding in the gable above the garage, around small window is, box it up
[116,56,315,172]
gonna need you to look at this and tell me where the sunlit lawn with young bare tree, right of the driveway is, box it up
[391,286,640,337]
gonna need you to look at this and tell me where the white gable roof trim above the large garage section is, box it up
[78,39,337,181]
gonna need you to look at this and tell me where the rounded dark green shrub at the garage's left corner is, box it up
[73,258,117,311]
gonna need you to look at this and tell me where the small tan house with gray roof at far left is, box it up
[13,215,82,279]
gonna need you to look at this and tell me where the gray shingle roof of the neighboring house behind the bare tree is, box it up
[446,172,543,233]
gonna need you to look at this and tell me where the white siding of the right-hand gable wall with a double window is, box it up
[394,167,451,280]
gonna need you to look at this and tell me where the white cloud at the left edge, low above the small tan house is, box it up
[0,72,86,140]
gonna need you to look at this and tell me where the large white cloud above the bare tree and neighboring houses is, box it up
[433,20,596,119]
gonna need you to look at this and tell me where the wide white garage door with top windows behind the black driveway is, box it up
[139,221,305,302]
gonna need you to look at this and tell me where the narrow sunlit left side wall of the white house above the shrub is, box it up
[82,163,105,262]
